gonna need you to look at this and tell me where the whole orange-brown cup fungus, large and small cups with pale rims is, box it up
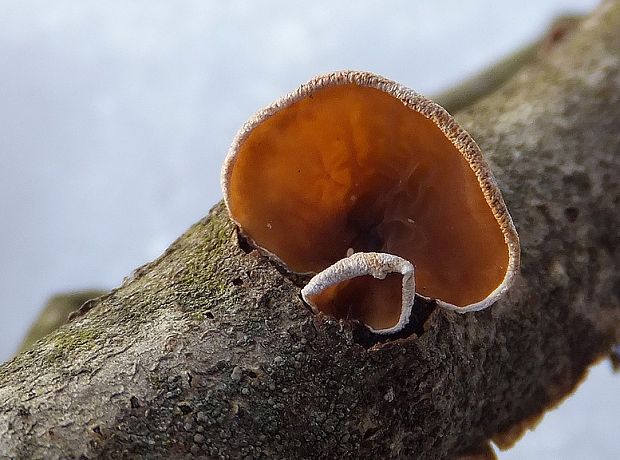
[222,71,519,333]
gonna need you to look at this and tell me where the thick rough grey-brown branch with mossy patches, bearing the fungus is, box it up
[0,2,620,458]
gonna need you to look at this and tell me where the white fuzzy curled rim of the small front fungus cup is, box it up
[301,252,415,334]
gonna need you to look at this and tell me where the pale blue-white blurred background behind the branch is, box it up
[0,0,620,459]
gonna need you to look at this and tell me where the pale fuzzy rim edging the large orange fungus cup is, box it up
[221,70,521,313]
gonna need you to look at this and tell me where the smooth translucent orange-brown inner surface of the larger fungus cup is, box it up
[228,84,509,311]
